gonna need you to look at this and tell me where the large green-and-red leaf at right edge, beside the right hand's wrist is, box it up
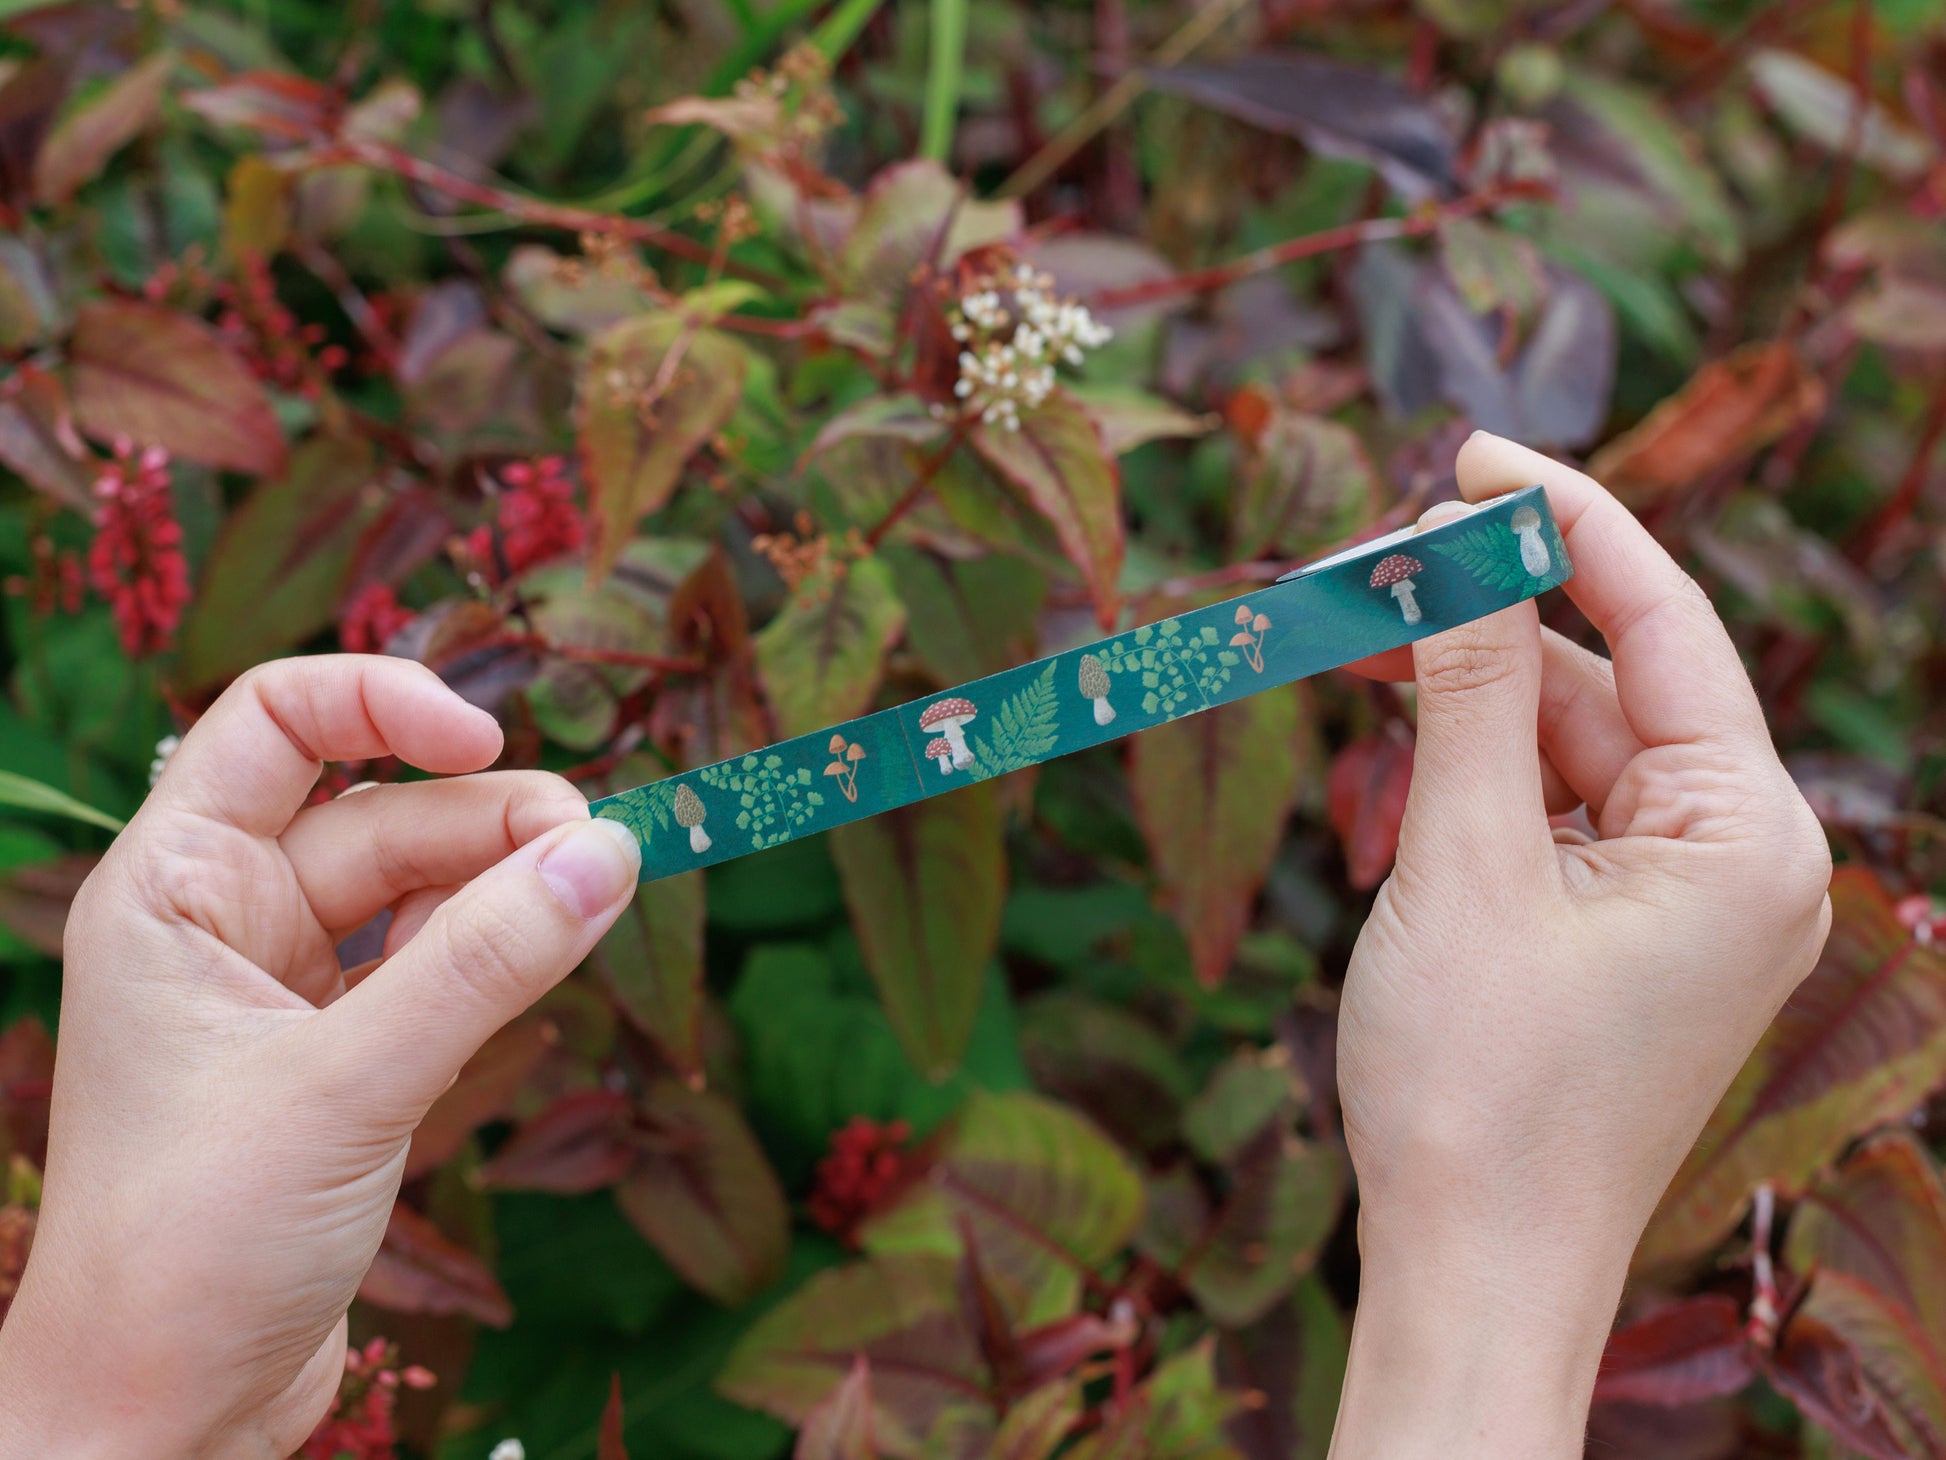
[1635,866,1946,1269]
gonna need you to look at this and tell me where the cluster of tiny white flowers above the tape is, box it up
[934,265,1115,430]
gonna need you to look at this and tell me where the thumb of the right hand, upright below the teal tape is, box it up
[1399,508,1549,866]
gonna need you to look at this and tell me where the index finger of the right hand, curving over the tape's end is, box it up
[1458,430,1771,749]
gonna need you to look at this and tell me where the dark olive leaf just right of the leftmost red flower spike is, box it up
[177,436,385,689]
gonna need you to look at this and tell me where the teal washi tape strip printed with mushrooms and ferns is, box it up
[594,487,1574,882]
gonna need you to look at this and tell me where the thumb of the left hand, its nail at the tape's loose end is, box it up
[323,816,642,1119]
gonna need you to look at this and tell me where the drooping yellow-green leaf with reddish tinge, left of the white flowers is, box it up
[580,310,749,576]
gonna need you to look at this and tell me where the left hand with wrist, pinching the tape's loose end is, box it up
[0,656,640,1460]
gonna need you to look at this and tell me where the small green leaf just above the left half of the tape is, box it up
[757,557,905,738]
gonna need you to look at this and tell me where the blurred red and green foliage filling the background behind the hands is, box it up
[0,0,1946,1460]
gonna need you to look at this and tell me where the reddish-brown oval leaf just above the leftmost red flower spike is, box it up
[68,300,284,477]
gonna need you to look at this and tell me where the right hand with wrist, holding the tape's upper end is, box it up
[1333,434,1831,1460]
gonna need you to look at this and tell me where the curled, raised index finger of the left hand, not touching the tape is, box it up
[154,654,500,837]
